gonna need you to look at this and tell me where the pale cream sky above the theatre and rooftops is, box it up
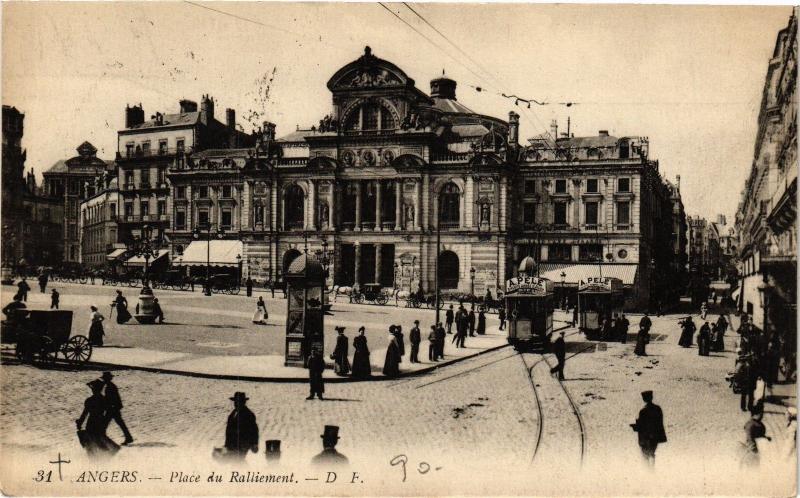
[2,2,791,223]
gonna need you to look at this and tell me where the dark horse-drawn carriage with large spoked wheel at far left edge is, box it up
[4,310,92,365]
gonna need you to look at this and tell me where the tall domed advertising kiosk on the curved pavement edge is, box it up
[284,254,325,367]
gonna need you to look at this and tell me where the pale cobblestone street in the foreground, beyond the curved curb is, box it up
[0,296,794,495]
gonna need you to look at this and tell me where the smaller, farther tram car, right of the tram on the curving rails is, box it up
[578,277,625,339]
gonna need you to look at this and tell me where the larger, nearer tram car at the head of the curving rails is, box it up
[504,276,553,352]
